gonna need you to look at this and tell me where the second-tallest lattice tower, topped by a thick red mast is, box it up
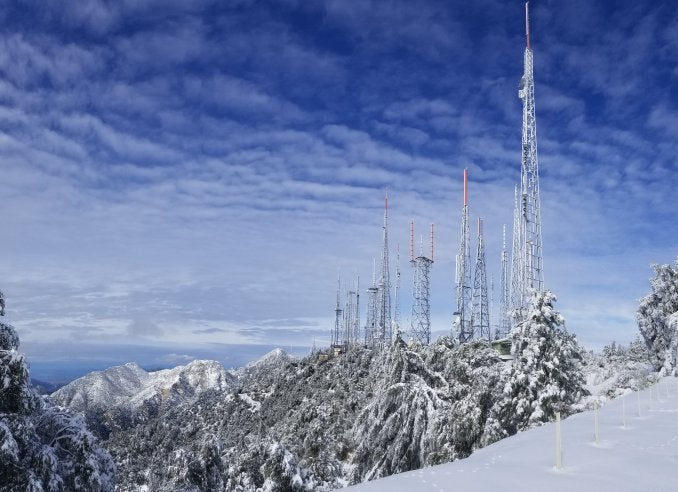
[452,169,473,343]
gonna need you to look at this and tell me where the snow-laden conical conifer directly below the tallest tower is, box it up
[503,290,584,433]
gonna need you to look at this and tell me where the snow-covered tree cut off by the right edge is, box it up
[636,260,678,374]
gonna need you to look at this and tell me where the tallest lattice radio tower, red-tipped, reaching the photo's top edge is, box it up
[511,2,544,321]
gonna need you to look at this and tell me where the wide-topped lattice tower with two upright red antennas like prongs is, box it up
[410,222,433,345]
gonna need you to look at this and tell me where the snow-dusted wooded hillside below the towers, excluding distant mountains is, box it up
[101,339,564,491]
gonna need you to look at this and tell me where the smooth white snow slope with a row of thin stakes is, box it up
[352,377,678,492]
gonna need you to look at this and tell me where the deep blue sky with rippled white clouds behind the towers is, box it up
[0,0,678,380]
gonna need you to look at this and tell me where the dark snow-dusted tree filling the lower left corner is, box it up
[0,306,115,492]
